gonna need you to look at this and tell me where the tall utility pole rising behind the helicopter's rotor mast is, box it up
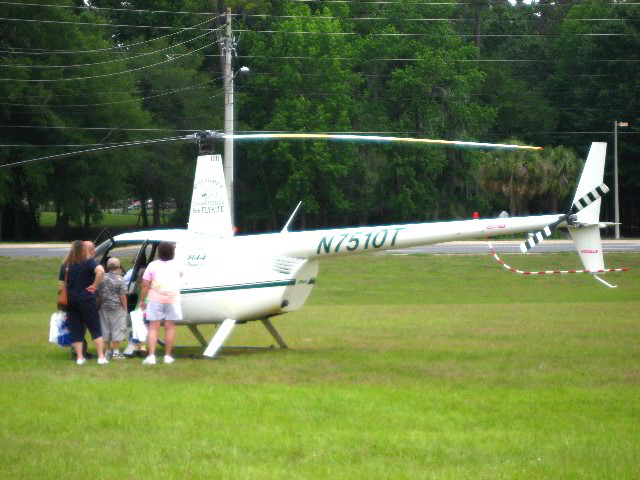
[222,8,236,227]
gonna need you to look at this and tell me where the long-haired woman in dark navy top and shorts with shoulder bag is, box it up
[58,240,109,365]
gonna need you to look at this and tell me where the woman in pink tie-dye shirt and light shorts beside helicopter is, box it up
[140,242,183,365]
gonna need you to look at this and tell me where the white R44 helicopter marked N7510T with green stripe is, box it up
[87,134,613,357]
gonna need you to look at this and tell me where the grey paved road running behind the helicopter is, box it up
[0,240,640,258]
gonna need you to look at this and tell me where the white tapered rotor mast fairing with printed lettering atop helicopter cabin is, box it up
[188,155,233,237]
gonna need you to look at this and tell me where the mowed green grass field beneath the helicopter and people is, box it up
[0,254,640,479]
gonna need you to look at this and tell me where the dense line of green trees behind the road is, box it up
[0,0,640,240]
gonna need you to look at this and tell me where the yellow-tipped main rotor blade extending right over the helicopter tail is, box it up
[228,133,542,150]
